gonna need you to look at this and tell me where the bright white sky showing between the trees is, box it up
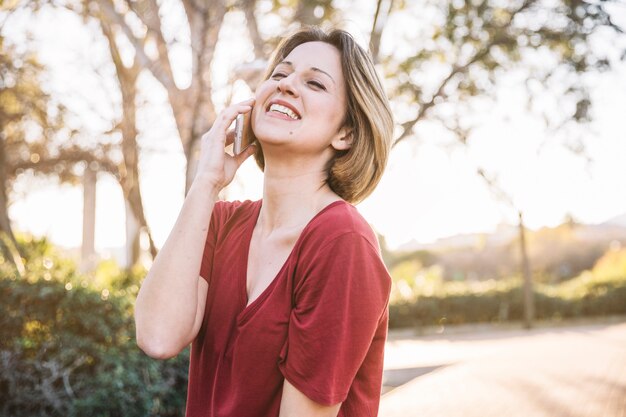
[3,0,626,260]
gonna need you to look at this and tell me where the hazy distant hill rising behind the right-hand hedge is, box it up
[385,215,626,282]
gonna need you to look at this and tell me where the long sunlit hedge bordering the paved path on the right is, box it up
[390,244,626,327]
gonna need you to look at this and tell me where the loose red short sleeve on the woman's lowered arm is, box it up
[279,232,391,405]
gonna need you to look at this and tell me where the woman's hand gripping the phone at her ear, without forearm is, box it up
[195,98,256,191]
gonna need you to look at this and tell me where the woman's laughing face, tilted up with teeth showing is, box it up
[251,42,347,154]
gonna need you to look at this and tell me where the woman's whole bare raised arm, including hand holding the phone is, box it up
[135,100,254,359]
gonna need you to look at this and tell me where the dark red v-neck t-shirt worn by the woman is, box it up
[187,201,391,417]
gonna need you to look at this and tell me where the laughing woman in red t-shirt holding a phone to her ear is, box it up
[135,28,393,417]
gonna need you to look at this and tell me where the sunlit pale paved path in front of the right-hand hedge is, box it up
[379,321,626,417]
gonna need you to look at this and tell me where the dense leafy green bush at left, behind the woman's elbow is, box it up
[0,237,188,416]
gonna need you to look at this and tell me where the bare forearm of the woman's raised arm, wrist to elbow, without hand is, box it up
[135,180,217,359]
